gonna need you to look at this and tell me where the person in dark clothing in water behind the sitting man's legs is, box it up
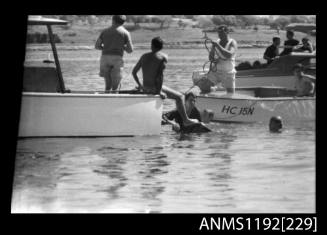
[163,92,201,132]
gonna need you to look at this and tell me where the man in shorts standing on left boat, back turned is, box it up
[95,15,133,92]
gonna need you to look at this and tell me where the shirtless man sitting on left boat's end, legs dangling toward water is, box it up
[132,37,199,126]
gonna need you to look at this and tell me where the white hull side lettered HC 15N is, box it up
[196,96,316,123]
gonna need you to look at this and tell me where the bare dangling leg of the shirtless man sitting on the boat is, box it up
[161,85,198,125]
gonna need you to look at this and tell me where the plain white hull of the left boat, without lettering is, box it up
[18,92,163,137]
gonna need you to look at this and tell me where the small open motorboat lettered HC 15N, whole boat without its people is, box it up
[195,86,316,124]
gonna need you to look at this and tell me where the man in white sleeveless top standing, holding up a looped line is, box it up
[208,25,237,94]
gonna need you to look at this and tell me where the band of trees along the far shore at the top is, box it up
[42,15,316,29]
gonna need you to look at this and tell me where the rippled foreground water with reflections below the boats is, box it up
[12,121,315,213]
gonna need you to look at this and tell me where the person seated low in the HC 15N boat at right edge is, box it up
[293,64,316,96]
